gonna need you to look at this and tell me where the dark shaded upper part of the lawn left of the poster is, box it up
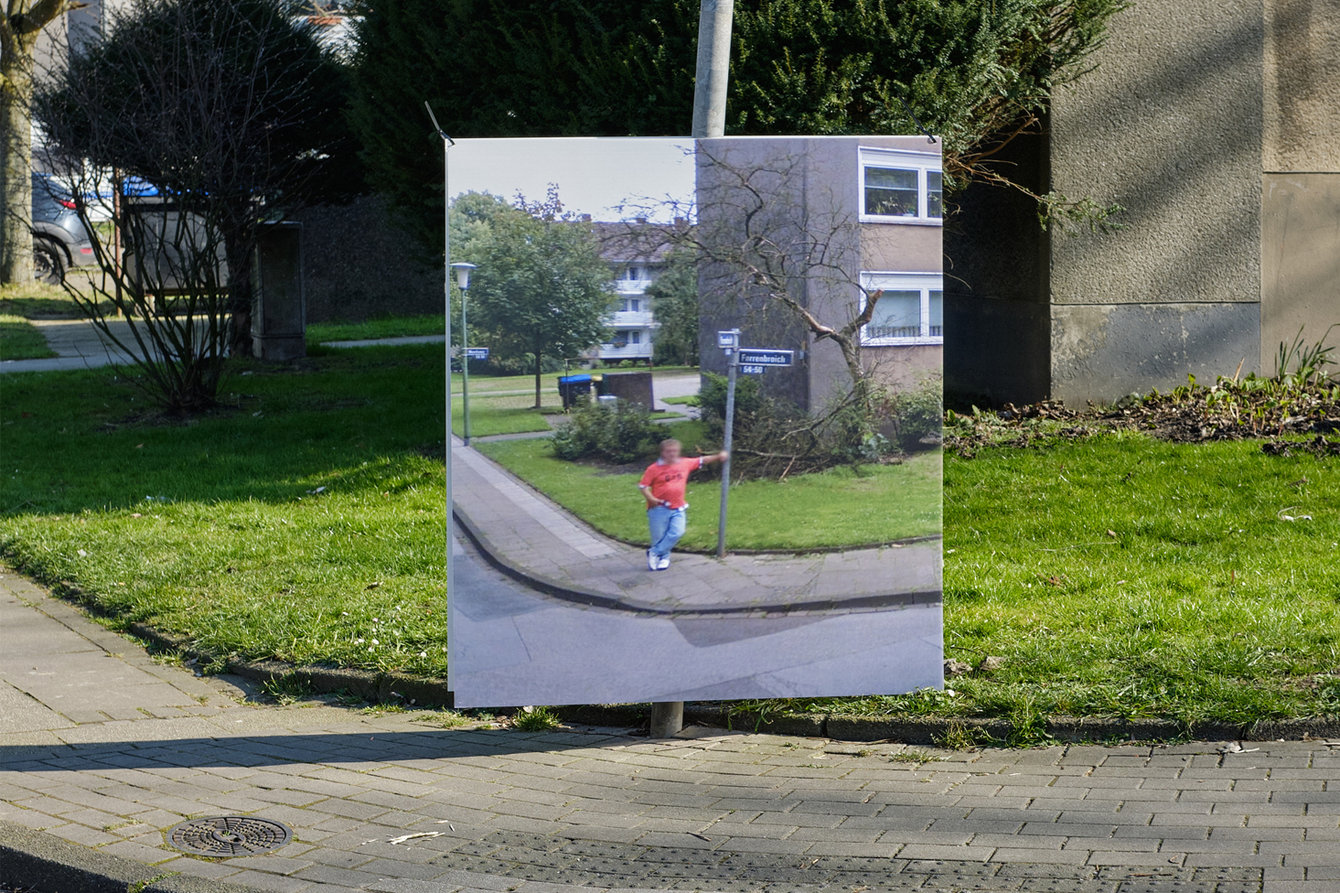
[0,346,444,518]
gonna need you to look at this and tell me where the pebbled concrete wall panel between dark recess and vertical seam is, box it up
[1051,0,1265,402]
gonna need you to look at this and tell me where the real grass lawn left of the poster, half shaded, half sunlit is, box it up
[0,347,446,674]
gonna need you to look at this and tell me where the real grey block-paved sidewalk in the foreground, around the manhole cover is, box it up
[0,565,1340,893]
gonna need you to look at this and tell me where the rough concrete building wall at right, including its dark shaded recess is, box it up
[946,0,1340,404]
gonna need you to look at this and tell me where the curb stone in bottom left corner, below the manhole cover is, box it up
[0,822,269,893]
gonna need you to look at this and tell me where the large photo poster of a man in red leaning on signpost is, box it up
[448,137,943,707]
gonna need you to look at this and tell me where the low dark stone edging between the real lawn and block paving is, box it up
[13,571,1340,746]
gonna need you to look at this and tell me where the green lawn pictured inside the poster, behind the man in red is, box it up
[477,431,939,550]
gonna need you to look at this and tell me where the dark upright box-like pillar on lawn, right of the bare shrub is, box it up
[252,223,307,361]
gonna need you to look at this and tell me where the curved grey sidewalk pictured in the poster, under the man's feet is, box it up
[453,440,941,614]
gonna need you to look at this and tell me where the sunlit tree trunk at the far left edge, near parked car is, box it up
[0,27,38,286]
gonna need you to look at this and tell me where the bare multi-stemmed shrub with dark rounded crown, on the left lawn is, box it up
[35,0,354,412]
